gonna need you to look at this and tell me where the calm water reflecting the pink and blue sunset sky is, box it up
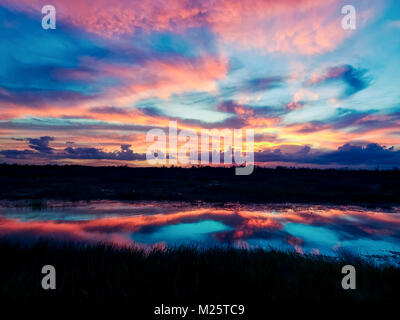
[0,201,400,260]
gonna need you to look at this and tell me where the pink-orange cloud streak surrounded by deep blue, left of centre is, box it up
[67,56,228,101]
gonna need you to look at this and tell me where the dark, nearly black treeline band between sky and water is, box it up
[0,164,400,206]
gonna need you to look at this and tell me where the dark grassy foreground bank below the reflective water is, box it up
[0,240,400,307]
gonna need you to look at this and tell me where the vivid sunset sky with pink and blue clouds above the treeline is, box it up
[0,0,400,168]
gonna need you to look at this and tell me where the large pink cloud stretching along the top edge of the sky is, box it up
[0,0,372,54]
